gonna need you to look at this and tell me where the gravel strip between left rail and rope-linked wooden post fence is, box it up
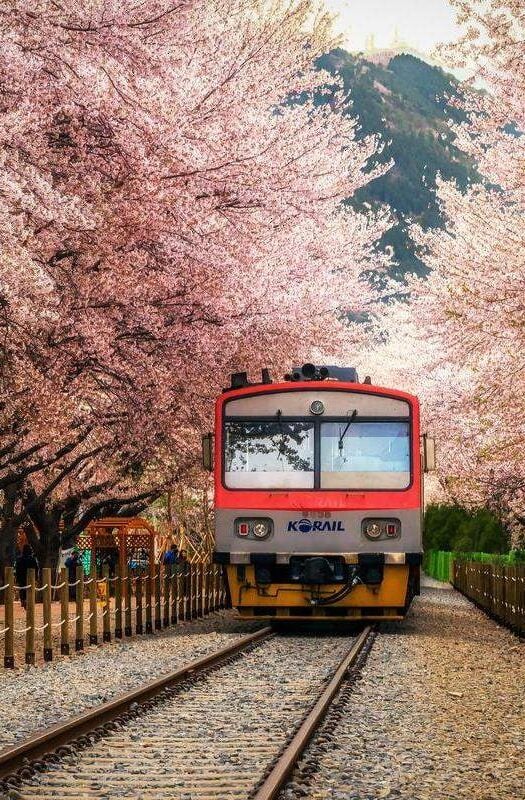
[0,611,262,749]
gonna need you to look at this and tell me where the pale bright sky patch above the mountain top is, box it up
[325,0,459,54]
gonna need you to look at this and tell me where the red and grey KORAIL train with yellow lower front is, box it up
[203,364,435,622]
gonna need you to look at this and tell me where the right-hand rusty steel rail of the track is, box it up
[252,625,372,800]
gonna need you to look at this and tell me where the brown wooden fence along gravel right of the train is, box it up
[453,561,525,636]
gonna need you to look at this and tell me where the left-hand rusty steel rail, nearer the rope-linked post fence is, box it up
[0,627,274,780]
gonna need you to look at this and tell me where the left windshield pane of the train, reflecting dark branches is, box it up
[224,421,314,489]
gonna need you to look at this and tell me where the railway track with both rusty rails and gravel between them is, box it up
[0,628,370,800]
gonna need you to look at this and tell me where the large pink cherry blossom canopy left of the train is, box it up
[0,0,388,561]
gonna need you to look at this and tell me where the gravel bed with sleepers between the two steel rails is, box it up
[17,633,353,800]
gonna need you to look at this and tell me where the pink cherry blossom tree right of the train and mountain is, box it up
[364,0,525,545]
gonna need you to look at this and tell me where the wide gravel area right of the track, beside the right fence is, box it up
[283,584,525,800]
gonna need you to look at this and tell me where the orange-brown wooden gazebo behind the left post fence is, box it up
[77,517,162,574]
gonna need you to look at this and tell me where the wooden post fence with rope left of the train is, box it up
[0,564,228,668]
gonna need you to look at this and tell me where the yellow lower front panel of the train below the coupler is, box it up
[226,564,412,620]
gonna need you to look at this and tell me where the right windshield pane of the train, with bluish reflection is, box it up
[320,420,410,489]
